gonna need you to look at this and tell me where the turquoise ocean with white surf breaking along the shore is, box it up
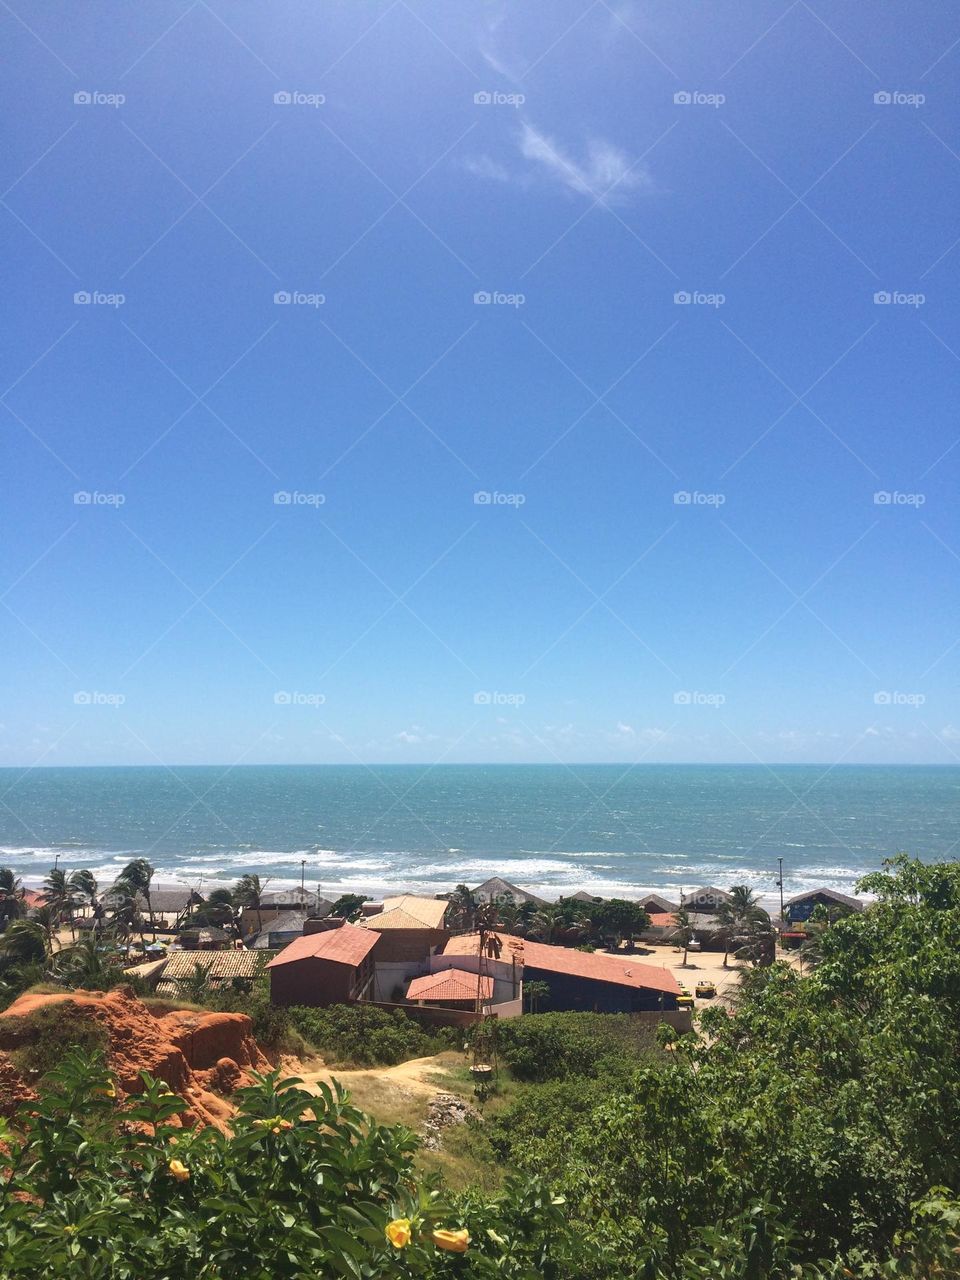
[0,764,960,900]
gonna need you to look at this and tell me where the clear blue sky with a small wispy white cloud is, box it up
[0,0,960,767]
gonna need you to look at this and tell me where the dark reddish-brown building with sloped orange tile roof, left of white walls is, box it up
[266,924,381,1007]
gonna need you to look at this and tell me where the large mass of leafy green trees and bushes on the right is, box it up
[477,858,960,1277]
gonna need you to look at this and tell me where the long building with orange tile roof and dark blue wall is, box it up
[440,933,680,1014]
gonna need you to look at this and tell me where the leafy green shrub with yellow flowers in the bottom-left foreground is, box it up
[0,1052,577,1280]
